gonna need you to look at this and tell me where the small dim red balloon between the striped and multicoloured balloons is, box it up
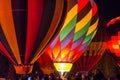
[37,52,55,75]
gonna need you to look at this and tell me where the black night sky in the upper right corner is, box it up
[95,0,120,21]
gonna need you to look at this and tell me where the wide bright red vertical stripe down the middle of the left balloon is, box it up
[24,0,43,64]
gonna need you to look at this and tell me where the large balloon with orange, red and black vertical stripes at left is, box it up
[0,0,66,74]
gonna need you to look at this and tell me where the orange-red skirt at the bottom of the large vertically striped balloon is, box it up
[14,64,33,74]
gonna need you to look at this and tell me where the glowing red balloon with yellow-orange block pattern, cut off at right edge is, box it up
[107,17,120,66]
